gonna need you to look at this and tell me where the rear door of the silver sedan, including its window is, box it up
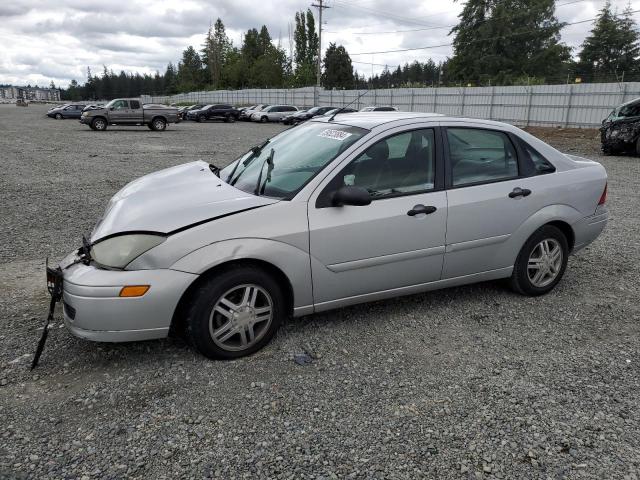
[442,125,544,279]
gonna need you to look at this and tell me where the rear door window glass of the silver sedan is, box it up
[447,128,519,186]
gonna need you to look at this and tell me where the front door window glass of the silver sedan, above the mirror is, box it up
[336,128,435,199]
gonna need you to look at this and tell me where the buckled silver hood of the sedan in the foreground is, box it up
[91,161,278,242]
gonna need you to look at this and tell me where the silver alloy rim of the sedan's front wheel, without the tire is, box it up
[209,284,273,351]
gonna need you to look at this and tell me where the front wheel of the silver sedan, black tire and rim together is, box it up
[186,265,286,360]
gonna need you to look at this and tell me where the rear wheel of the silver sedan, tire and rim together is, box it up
[511,225,569,297]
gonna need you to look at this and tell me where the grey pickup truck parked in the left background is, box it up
[80,98,179,132]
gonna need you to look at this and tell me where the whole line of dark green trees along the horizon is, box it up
[62,0,640,100]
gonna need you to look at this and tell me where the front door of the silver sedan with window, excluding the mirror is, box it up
[308,127,447,309]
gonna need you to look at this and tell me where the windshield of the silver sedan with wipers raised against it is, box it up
[220,123,368,199]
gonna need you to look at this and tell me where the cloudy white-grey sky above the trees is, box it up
[0,0,640,87]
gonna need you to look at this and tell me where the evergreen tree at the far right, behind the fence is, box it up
[577,1,640,79]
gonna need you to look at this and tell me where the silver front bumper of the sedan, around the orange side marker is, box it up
[62,254,197,342]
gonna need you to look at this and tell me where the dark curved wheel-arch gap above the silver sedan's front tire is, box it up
[169,258,294,334]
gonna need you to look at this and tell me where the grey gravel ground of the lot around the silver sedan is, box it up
[0,105,640,479]
